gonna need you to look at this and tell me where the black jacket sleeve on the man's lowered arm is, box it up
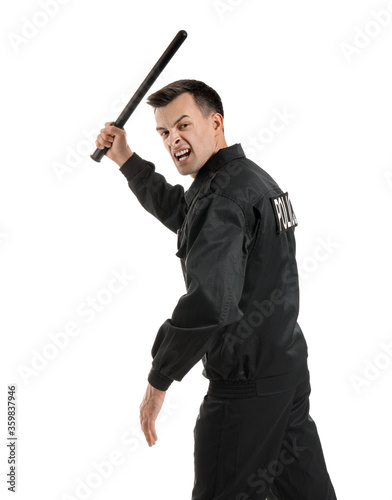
[148,194,248,391]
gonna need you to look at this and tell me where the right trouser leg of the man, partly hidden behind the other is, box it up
[268,378,336,500]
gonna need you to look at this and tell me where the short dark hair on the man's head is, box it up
[147,80,224,118]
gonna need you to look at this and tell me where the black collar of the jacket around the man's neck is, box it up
[184,144,245,206]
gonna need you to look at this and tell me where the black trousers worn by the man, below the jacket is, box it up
[192,373,336,500]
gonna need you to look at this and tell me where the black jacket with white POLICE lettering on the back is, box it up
[120,144,307,391]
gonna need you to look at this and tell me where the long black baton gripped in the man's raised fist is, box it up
[90,30,188,162]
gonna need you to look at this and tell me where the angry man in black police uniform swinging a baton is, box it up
[96,80,336,500]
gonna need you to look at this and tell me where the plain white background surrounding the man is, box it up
[0,0,392,500]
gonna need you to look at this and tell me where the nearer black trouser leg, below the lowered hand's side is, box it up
[192,388,296,500]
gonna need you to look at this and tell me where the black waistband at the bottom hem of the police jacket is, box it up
[207,365,309,399]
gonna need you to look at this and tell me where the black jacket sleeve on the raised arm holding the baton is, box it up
[120,153,186,233]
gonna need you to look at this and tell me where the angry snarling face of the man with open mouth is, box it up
[155,93,227,177]
